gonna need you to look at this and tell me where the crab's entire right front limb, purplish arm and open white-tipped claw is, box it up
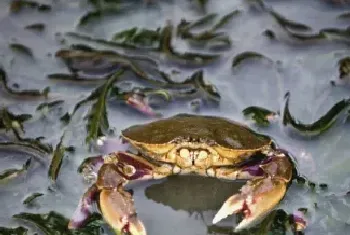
[213,151,293,232]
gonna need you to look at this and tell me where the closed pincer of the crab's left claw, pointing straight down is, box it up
[100,190,147,235]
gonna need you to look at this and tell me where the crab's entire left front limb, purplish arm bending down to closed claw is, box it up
[70,152,173,235]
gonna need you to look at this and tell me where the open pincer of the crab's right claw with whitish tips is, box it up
[213,177,287,232]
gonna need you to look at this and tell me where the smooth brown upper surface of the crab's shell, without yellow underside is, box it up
[122,114,271,150]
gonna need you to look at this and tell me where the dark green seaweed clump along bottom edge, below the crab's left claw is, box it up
[13,211,104,235]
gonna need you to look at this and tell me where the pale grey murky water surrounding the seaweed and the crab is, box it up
[0,0,350,235]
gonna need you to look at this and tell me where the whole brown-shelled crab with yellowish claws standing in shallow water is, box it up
[68,114,305,235]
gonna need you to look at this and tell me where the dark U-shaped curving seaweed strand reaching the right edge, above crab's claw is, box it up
[282,92,350,137]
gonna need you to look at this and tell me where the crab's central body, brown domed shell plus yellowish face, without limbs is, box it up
[121,114,273,170]
